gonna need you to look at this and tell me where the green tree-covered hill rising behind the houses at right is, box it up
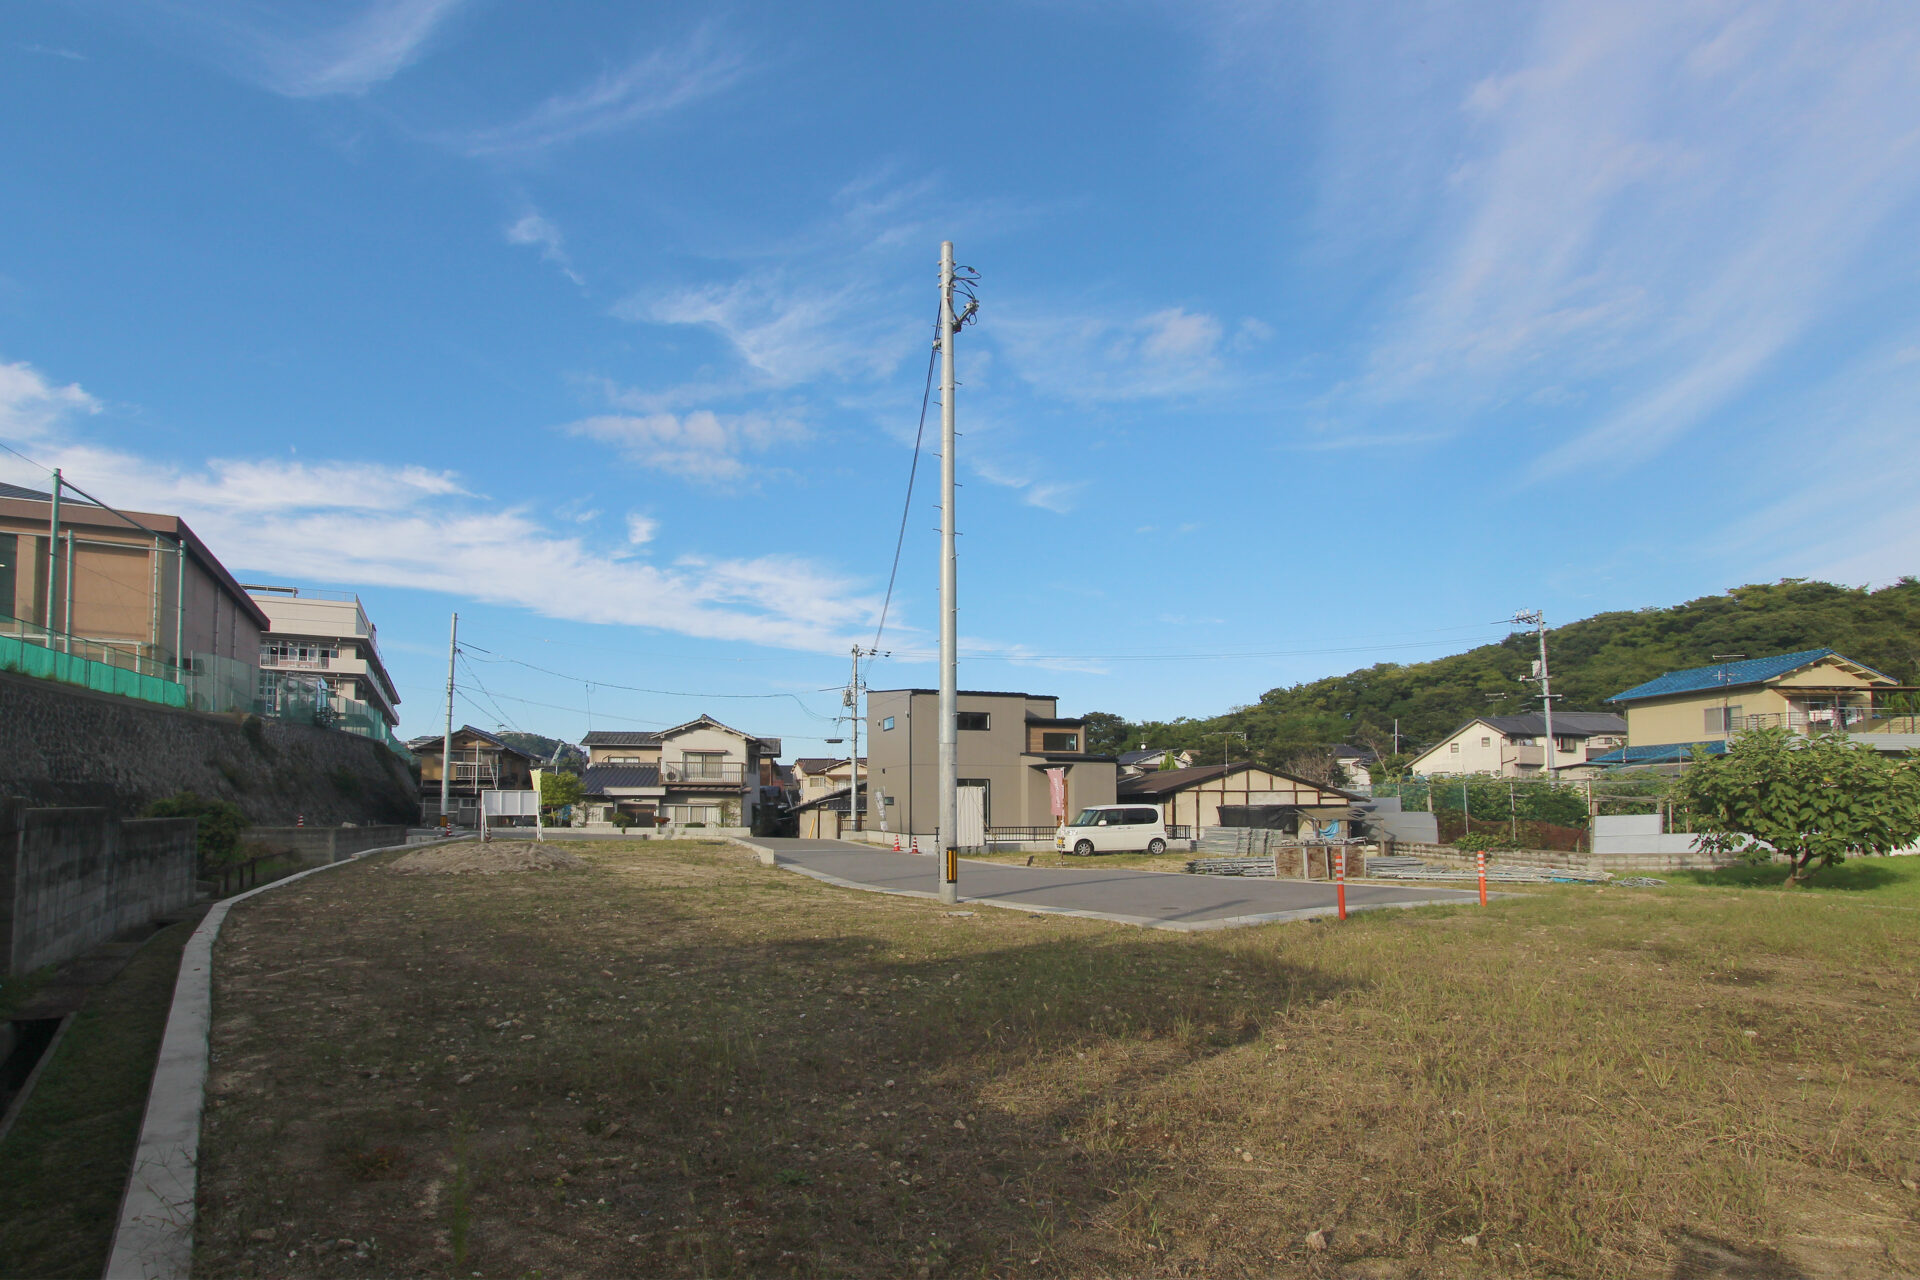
[1087,578,1920,773]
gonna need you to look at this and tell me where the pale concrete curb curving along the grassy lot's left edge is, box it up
[106,844,419,1280]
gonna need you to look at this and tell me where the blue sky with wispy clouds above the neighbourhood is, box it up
[0,0,1920,756]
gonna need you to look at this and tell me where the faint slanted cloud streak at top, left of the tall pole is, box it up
[459,25,747,155]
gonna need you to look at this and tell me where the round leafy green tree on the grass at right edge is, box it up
[1676,729,1920,885]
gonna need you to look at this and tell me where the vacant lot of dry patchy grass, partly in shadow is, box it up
[194,844,1920,1278]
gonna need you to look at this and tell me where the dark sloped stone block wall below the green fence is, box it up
[0,672,420,827]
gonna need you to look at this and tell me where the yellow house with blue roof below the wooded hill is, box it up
[1607,649,1916,744]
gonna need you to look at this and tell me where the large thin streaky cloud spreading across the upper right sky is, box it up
[1329,0,1920,480]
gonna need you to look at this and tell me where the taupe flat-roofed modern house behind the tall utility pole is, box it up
[862,689,1116,837]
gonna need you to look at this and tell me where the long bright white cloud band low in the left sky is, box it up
[0,355,879,652]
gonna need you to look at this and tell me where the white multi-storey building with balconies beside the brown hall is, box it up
[248,585,399,729]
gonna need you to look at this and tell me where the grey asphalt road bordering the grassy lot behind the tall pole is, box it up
[747,837,1475,929]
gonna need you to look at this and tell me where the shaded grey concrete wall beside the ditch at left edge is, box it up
[0,800,196,975]
